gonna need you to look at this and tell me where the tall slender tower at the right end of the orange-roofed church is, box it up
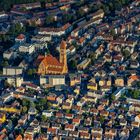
[59,40,68,73]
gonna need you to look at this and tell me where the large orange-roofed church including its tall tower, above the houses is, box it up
[37,40,68,75]
